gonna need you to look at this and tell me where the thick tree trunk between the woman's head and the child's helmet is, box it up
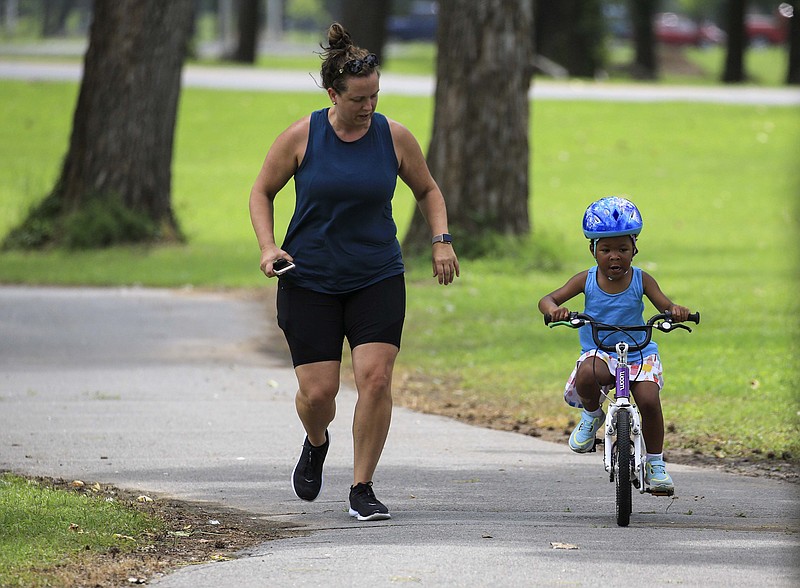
[403,0,533,256]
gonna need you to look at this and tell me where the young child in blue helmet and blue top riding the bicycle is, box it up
[539,196,689,490]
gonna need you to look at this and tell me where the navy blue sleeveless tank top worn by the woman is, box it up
[281,108,404,294]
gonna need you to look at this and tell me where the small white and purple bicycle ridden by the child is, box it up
[544,312,700,527]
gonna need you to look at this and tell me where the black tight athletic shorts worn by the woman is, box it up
[277,274,406,367]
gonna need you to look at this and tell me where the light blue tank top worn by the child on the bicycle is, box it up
[579,266,658,364]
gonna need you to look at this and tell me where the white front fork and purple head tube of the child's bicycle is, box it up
[603,342,647,494]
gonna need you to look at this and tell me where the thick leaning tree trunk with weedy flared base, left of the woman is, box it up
[5,0,194,248]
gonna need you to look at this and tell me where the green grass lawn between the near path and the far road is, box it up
[0,82,800,459]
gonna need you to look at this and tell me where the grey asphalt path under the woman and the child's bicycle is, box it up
[0,287,800,588]
